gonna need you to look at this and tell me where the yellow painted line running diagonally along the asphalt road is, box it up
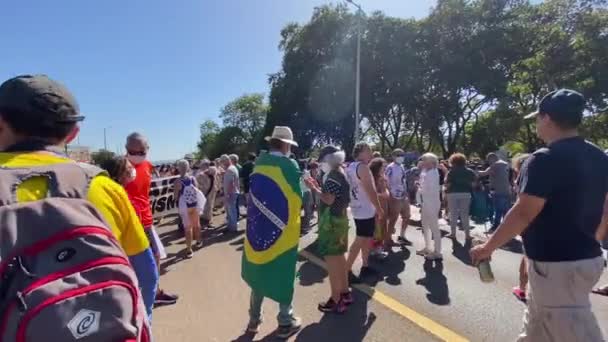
[300,250,469,342]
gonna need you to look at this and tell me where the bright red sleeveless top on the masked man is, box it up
[125,160,154,228]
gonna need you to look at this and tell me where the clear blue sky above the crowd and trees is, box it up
[0,0,435,160]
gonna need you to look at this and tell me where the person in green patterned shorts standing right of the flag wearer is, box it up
[304,145,353,313]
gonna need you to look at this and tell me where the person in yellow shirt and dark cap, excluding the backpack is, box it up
[0,75,158,318]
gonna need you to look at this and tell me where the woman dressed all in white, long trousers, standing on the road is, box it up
[416,153,443,260]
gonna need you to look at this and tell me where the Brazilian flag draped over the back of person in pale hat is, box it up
[241,153,302,304]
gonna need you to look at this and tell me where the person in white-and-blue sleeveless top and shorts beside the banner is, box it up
[174,159,204,259]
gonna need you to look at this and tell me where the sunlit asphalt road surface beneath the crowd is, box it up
[153,209,608,342]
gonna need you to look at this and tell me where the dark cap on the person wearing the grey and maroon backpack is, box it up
[0,75,84,123]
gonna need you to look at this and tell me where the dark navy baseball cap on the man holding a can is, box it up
[526,89,585,126]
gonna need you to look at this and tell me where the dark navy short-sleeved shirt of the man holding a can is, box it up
[519,137,608,262]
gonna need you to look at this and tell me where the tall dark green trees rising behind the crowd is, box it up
[201,0,608,160]
